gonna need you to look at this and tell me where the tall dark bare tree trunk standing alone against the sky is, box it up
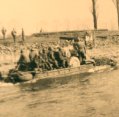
[92,0,98,29]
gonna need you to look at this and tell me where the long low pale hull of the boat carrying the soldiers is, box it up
[9,65,110,82]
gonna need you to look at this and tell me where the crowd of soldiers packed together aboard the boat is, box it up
[16,38,91,71]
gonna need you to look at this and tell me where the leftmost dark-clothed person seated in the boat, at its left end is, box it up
[16,50,30,71]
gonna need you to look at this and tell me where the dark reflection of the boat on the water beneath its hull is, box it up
[20,73,91,91]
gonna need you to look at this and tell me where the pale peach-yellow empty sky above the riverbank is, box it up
[0,0,117,34]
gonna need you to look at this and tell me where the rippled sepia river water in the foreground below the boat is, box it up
[0,70,119,117]
